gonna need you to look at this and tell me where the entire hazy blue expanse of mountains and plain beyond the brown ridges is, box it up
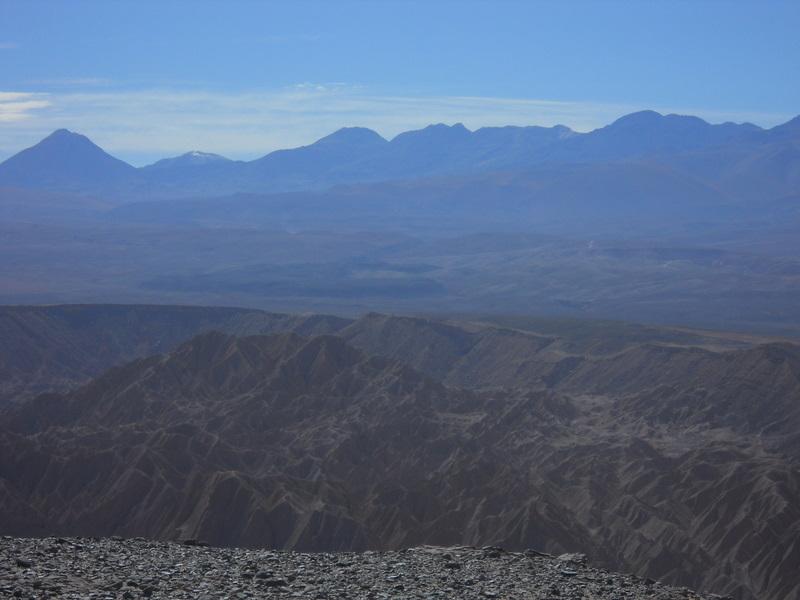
[0,111,800,336]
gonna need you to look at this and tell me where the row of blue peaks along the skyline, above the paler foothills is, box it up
[0,111,800,200]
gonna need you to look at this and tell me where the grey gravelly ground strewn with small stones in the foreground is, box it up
[0,537,732,600]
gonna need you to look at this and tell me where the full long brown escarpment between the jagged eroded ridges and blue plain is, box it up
[0,304,768,404]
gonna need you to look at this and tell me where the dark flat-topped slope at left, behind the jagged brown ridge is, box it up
[0,304,350,403]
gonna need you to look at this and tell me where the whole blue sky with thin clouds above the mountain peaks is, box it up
[0,0,800,165]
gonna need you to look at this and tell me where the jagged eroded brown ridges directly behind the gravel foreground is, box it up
[0,330,800,600]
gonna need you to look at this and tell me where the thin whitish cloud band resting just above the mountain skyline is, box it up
[0,83,792,165]
